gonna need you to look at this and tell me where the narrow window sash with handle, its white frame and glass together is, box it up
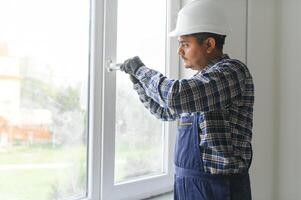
[102,0,178,200]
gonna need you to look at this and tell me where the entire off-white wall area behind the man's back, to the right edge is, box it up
[248,0,301,200]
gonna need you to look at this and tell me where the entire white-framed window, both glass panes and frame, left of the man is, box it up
[0,0,180,200]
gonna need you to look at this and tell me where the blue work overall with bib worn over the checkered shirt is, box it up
[174,113,251,200]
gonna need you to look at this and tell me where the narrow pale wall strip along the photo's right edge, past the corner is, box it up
[275,0,301,200]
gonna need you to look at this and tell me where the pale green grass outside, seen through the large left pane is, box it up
[0,146,86,200]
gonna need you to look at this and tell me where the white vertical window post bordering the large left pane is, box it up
[86,0,104,200]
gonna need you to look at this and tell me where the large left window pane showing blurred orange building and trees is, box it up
[0,0,90,200]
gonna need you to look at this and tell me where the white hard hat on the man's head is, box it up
[168,0,230,37]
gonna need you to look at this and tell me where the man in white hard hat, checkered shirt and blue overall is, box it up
[121,0,254,200]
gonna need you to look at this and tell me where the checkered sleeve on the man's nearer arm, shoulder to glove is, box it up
[135,63,246,114]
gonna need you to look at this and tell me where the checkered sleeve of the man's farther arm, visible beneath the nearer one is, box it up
[133,83,178,121]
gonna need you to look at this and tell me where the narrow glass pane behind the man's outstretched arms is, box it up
[115,0,166,182]
